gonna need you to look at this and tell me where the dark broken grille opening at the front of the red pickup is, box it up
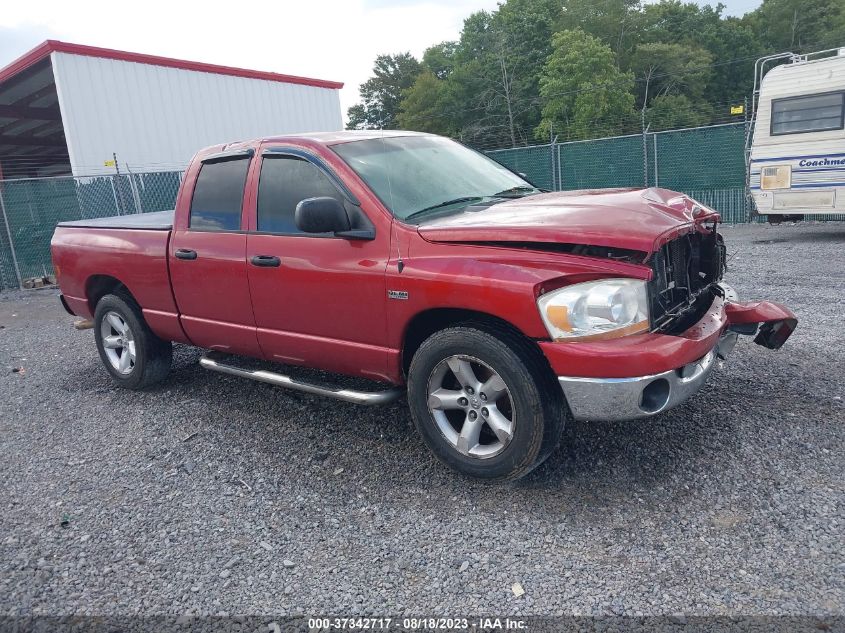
[648,227,725,334]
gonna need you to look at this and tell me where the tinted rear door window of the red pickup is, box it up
[189,157,249,231]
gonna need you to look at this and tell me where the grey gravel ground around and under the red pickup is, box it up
[0,223,845,615]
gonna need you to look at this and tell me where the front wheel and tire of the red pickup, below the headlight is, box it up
[408,323,568,480]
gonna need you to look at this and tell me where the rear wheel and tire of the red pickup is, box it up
[94,294,173,390]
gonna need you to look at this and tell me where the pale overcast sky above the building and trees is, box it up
[0,0,760,114]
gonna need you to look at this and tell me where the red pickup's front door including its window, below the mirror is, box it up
[242,149,390,378]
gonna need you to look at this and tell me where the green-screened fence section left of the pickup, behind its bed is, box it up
[0,171,182,288]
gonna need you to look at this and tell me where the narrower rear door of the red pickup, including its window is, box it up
[169,150,261,356]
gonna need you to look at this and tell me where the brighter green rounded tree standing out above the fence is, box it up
[535,29,634,139]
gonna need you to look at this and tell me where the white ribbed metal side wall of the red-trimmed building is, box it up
[52,53,343,175]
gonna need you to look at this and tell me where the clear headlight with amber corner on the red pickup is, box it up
[537,279,649,341]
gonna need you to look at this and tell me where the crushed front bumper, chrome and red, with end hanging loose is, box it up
[544,286,797,420]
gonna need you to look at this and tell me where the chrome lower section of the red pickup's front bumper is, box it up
[558,331,738,420]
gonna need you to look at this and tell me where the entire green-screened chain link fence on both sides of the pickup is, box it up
[0,123,845,288]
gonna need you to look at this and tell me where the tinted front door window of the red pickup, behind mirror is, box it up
[258,156,343,233]
